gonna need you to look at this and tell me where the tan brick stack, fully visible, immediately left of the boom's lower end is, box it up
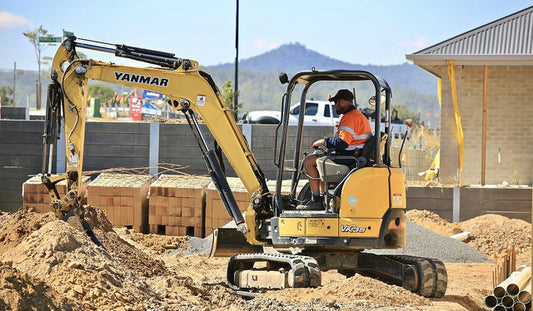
[149,175,211,237]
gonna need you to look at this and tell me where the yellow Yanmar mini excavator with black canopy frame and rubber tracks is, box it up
[42,37,447,297]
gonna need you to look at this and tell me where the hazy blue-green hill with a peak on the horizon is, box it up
[0,43,439,124]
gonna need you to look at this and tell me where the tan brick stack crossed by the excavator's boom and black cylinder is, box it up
[205,177,251,236]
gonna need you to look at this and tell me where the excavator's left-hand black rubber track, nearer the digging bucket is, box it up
[227,253,322,291]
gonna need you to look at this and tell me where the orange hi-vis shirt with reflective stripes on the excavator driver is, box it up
[337,109,372,150]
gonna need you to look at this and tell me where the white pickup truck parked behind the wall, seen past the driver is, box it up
[241,100,408,137]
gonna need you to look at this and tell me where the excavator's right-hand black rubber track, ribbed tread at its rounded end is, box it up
[388,255,448,298]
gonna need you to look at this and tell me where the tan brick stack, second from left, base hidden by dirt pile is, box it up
[87,173,152,233]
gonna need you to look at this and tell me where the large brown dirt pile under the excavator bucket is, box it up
[0,210,240,310]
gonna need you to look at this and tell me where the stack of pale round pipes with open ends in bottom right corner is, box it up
[485,265,531,311]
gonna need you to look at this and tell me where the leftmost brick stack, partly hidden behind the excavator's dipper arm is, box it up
[22,175,91,213]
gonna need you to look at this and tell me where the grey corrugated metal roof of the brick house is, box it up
[406,6,533,65]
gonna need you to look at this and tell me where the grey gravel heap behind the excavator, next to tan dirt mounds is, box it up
[176,221,491,263]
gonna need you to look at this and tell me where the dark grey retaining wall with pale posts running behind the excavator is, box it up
[0,120,531,220]
